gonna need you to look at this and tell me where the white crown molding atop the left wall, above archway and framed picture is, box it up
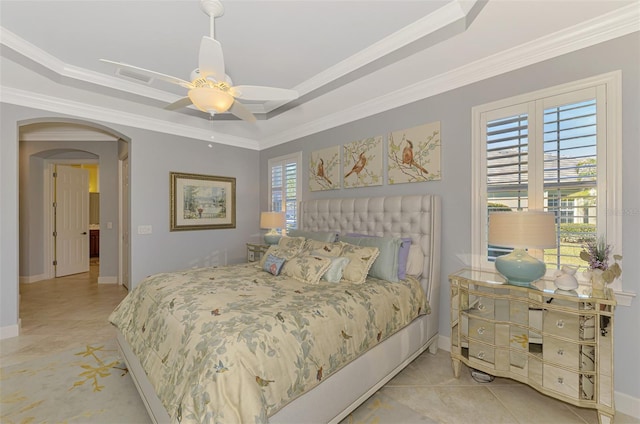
[0,86,259,150]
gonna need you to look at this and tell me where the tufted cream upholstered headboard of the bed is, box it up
[300,194,441,308]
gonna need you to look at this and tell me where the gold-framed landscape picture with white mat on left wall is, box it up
[169,172,236,231]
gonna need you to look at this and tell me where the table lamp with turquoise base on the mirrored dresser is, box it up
[489,211,557,287]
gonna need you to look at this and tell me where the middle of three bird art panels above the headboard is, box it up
[342,136,383,188]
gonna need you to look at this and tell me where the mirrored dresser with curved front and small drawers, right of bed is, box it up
[449,269,616,423]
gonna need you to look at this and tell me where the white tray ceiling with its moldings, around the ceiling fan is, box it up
[0,0,640,149]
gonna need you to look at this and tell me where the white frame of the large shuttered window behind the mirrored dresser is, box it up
[471,71,622,292]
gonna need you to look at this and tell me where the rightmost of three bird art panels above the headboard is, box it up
[387,121,442,184]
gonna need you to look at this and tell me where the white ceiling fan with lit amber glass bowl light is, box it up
[100,0,298,122]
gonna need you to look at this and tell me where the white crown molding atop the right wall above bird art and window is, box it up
[260,4,640,149]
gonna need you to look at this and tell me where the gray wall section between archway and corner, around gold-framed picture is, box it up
[121,129,260,287]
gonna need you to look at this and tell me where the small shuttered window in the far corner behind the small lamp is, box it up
[269,152,302,230]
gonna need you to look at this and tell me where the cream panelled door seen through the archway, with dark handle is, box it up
[55,165,89,277]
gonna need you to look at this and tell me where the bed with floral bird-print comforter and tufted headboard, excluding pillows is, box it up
[110,195,440,423]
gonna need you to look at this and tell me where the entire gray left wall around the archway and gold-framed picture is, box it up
[0,103,260,328]
